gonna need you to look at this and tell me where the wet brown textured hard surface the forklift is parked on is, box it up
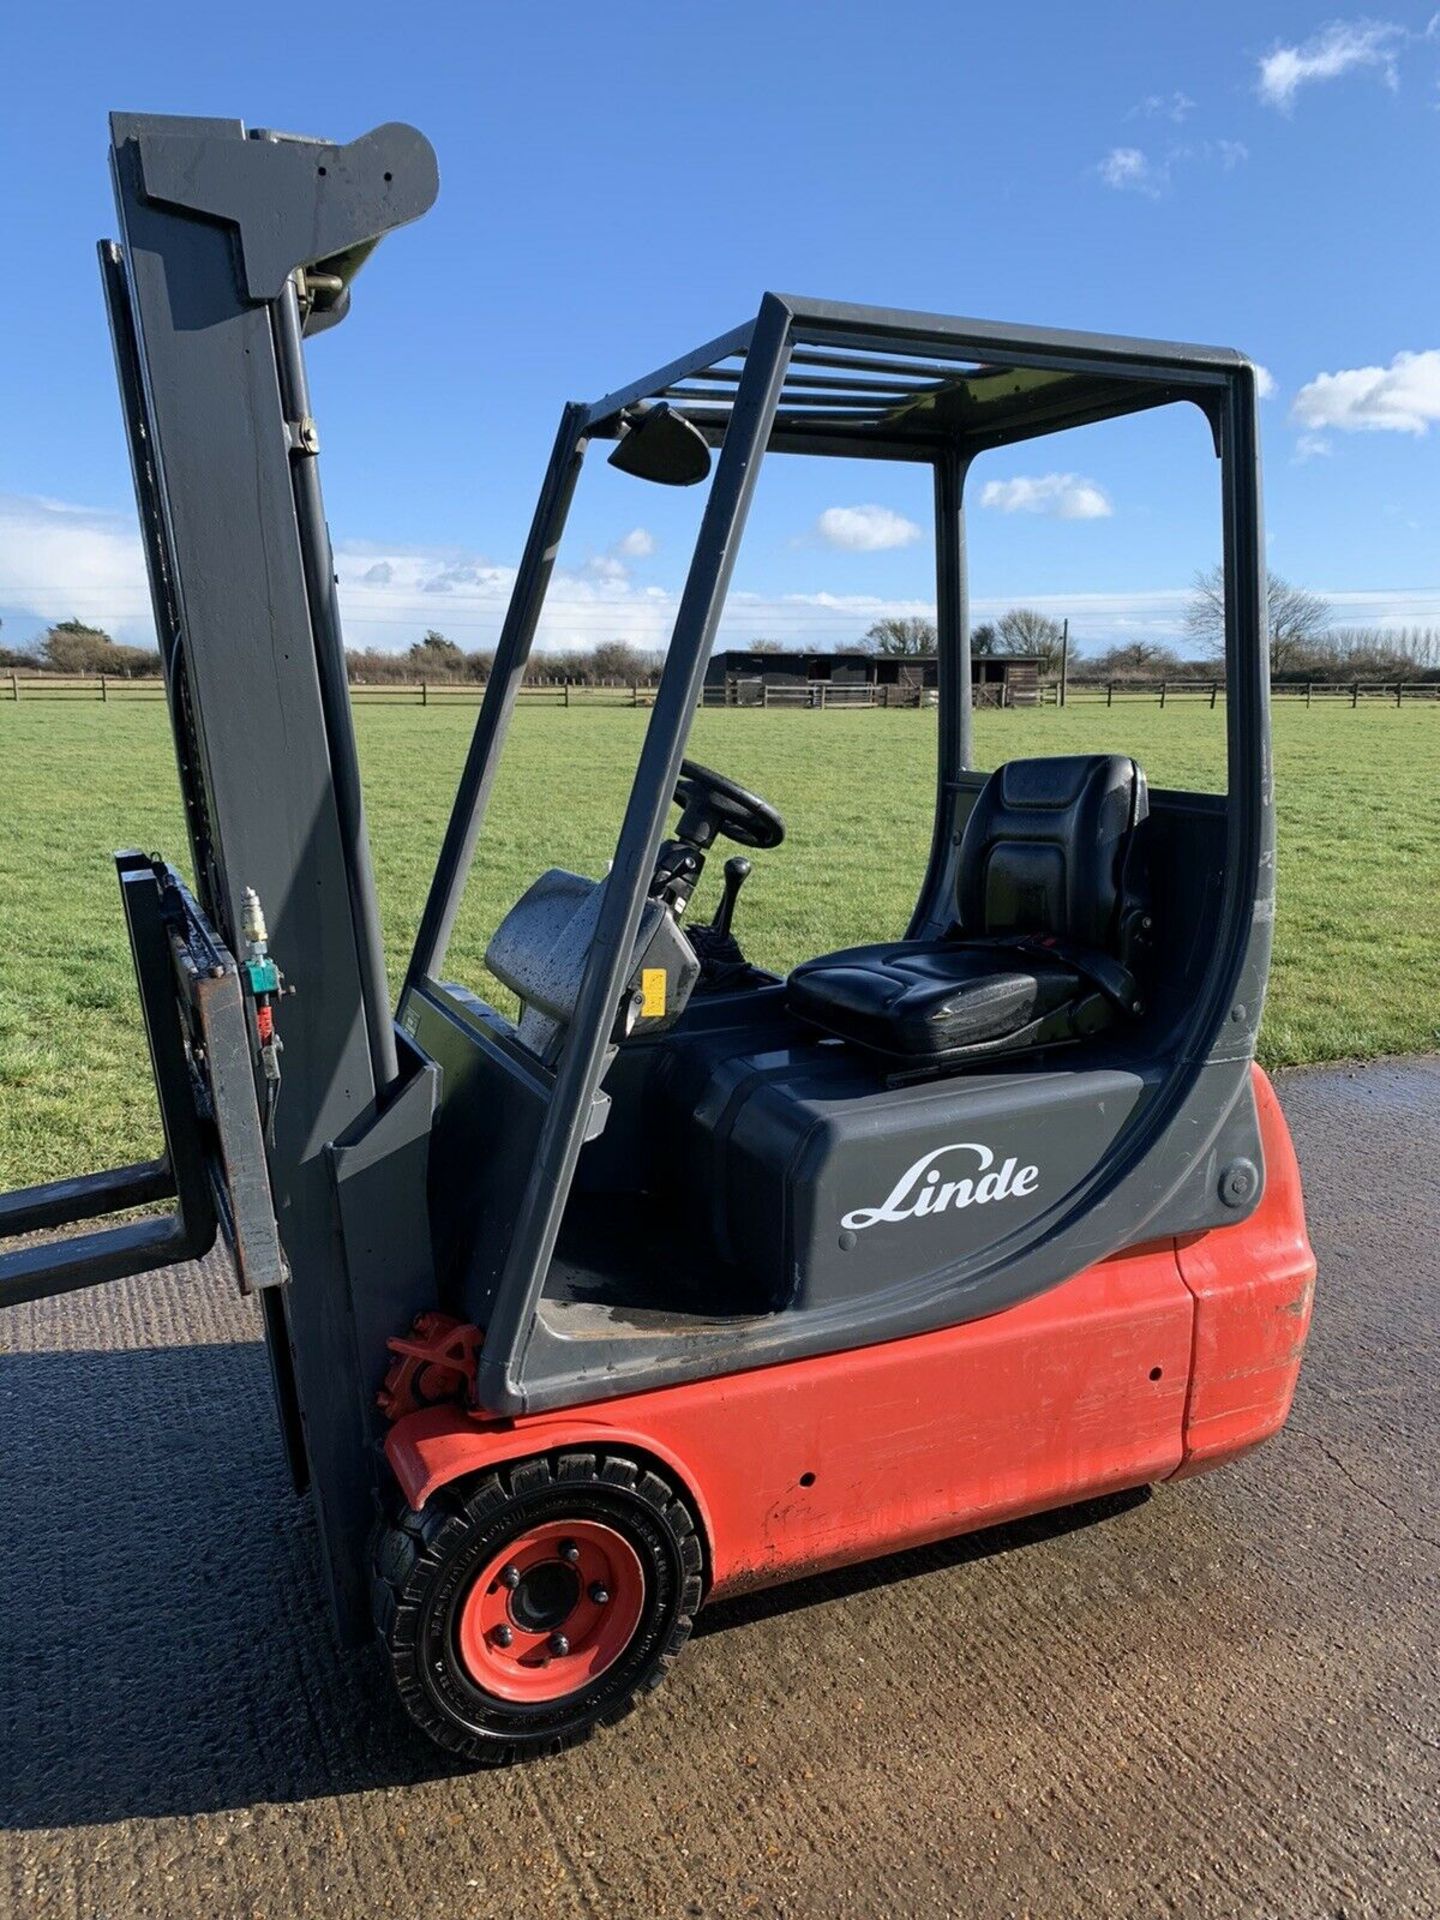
[0,1060,1440,1920]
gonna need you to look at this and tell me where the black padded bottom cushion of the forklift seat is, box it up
[785,941,1085,1064]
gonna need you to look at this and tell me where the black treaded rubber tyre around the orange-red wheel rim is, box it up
[372,1453,701,1766]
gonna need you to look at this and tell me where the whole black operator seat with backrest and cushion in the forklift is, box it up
[785,753,1150,1071]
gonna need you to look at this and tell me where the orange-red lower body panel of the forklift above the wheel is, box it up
[386,1068,1315,1597]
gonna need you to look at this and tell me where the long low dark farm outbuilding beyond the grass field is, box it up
[705,647,1041,707]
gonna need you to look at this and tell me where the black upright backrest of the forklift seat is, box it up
[956,753,1150,954]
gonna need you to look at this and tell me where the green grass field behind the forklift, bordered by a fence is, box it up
[0,703,1440,1188]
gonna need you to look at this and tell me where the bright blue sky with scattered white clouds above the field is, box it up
[0,0,1440,647]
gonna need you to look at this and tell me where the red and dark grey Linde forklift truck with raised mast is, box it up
[0,115,1313,1764]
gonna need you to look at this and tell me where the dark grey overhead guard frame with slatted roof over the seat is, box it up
[401,294,1273,1415]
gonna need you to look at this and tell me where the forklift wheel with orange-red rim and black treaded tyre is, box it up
[374,1453,701,1766]
